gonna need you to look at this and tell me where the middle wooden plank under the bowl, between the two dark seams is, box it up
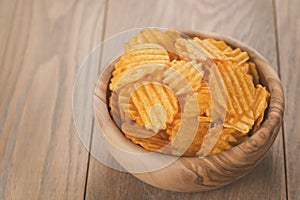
[87,0,286,199]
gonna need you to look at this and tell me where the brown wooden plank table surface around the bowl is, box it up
[0,0,300,199]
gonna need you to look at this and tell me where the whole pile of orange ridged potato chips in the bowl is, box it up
[109,29,269,156]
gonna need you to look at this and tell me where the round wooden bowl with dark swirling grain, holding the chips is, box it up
[94,31,284,192]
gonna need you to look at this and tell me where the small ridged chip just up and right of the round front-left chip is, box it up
[163,60,204,95]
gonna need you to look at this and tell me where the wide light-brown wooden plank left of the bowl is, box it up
[0,0,105,199]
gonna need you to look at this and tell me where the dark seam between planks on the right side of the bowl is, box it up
[272,0,289,200]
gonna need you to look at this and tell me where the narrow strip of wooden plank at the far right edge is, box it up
[275,0,300,199]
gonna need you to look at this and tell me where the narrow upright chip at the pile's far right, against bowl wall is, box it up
[253,84,270,132]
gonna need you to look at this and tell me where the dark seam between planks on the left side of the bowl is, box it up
[83,0,109,200]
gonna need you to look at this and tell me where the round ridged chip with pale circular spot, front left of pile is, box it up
[128,82,179,133]
